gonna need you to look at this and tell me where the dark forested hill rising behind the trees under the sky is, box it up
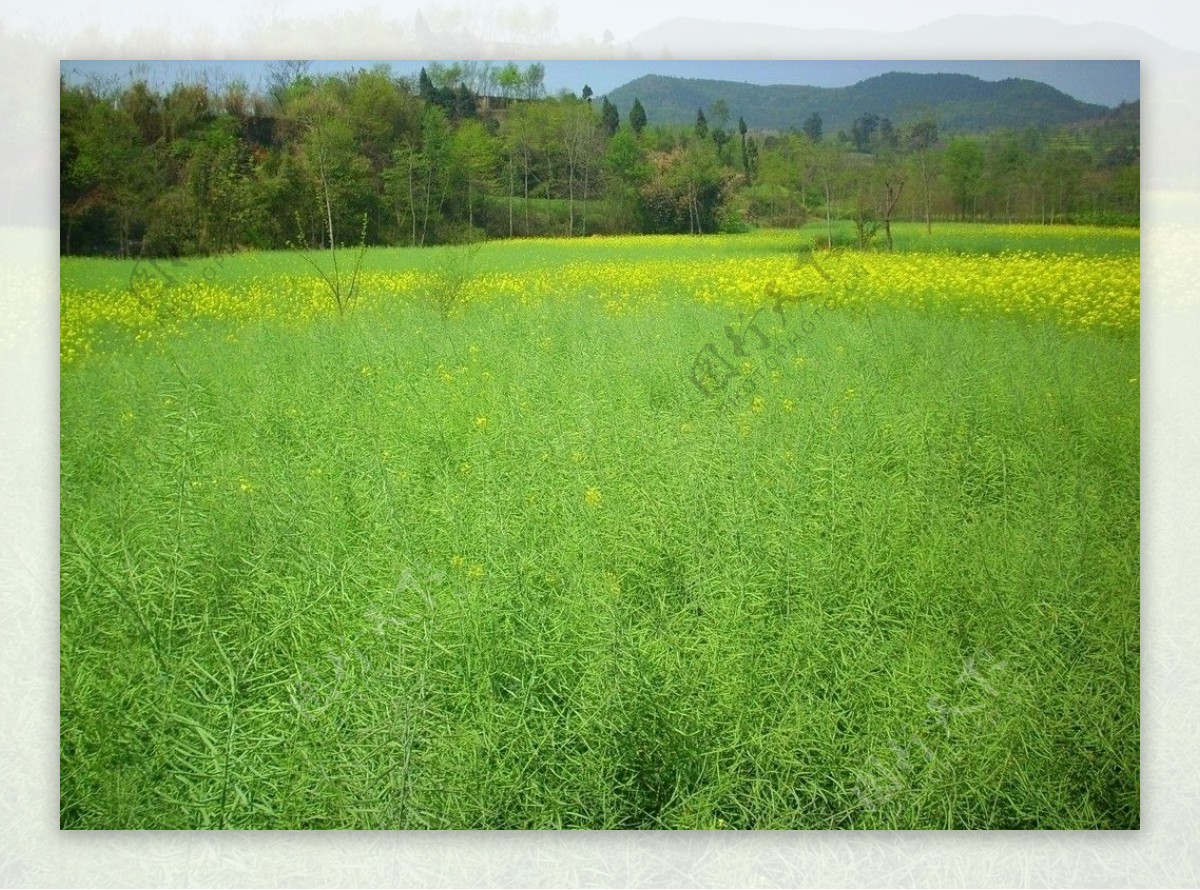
[608,72,1110,134]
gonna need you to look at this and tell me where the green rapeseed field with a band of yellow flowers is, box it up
[60,225,1140,829]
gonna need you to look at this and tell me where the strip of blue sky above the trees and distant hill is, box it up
[61,60,1140,106]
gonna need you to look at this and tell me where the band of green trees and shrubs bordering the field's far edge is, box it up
[60,61,1140,257]
